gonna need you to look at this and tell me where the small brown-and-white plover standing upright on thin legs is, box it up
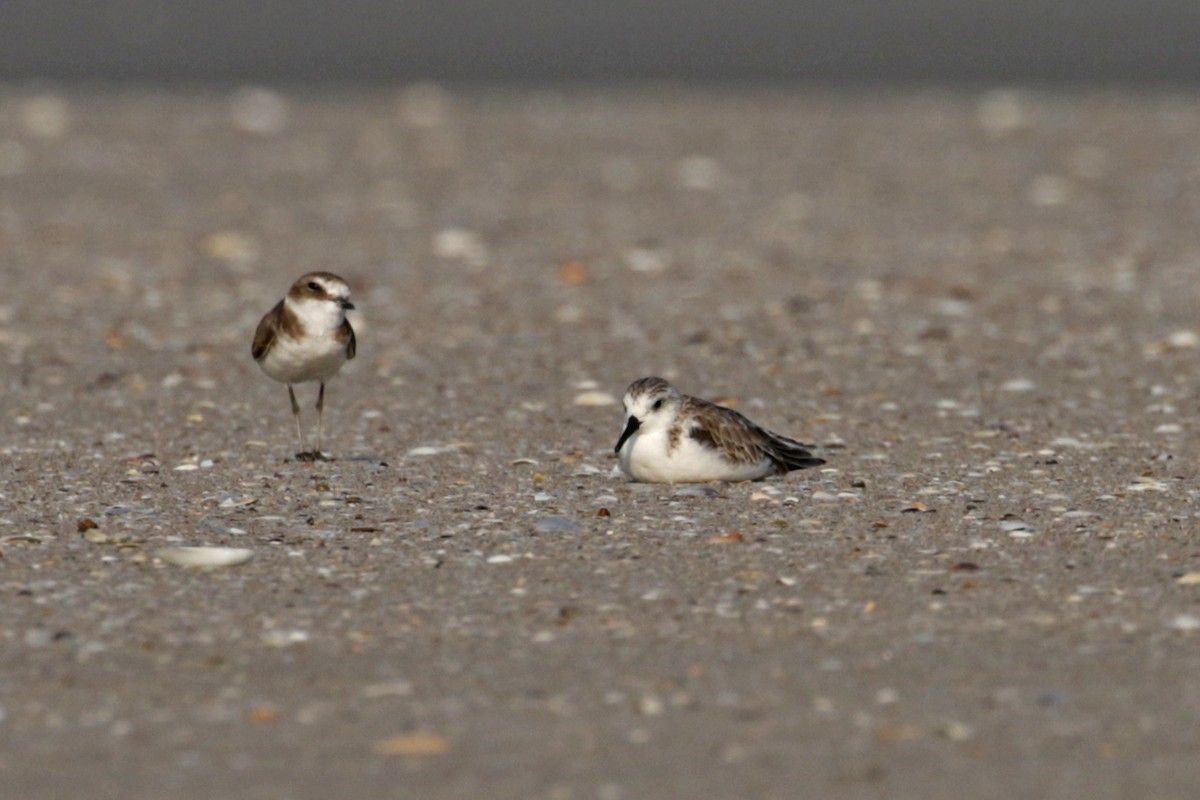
[251,272,356,461]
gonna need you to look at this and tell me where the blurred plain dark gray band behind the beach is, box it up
[0,0,1200,83]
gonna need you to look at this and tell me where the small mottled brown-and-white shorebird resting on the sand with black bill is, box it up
[614,378,824,483]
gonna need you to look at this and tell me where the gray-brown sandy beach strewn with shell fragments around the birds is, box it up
[0,85,1200,800]
